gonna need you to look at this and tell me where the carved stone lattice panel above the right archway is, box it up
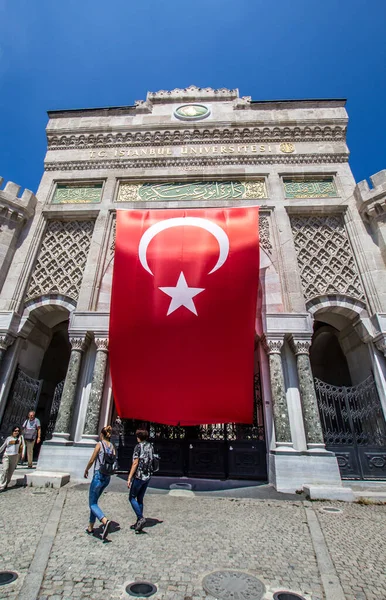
[290,215,365,301]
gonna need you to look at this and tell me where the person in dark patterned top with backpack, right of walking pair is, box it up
[127,429,153,533]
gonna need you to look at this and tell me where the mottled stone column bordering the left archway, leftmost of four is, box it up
[51,337,87,443]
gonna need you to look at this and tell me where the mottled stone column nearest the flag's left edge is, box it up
[82,338,109,442]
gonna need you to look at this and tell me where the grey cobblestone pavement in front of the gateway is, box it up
[0,488,386,600]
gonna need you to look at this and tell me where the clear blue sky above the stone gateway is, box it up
[0,0,386,191]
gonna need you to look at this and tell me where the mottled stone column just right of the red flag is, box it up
[263,336,292,447]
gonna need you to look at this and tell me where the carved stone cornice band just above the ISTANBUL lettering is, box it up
[47,124,346,150]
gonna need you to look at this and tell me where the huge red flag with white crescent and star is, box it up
[109,207,259,425]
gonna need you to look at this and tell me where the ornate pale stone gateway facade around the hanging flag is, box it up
[0,86,386,490]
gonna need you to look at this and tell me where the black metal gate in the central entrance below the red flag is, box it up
[114,376,267,481]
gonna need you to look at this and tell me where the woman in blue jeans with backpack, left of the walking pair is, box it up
[84,426,116,540]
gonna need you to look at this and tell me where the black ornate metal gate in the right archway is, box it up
[315,376,386,479]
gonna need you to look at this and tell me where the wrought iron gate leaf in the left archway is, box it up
[0,366,43,446]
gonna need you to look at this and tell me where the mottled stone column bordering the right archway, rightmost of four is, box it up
[290,336,325,450]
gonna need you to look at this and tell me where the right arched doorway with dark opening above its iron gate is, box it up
[310,307,386,479]
